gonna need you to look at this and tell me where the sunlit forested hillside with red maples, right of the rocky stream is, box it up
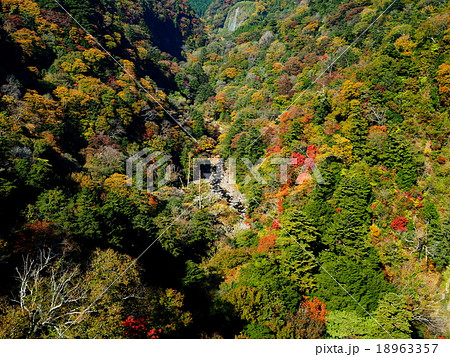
[183,1,450,338]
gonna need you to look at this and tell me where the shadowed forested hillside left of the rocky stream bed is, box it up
[0,0,216,338]
